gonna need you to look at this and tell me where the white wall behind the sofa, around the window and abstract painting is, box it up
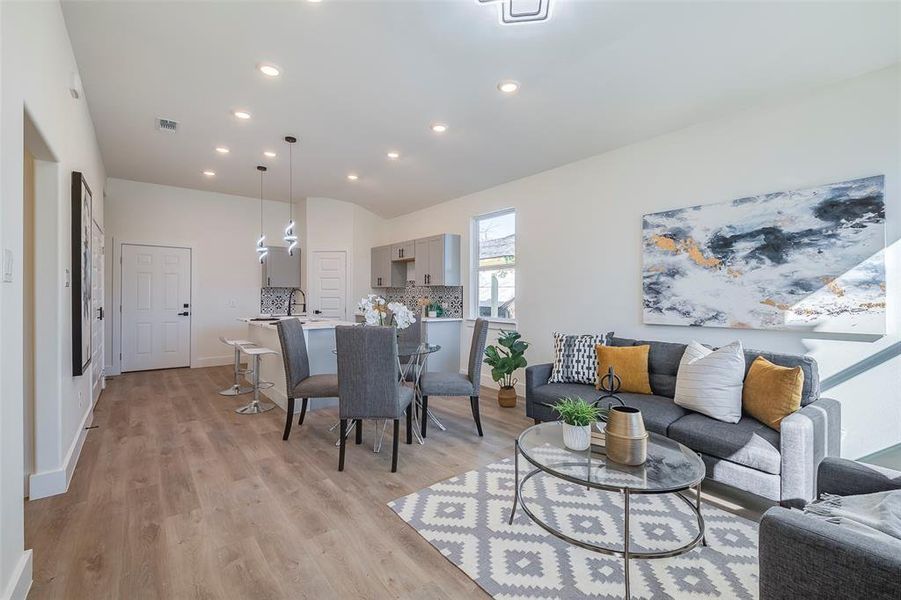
[378,67,901,457]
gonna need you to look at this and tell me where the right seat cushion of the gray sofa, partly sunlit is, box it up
[669,413,782,475]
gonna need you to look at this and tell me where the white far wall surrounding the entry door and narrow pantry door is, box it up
[105,183,378,372]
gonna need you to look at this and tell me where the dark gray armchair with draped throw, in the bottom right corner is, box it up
[759,458,901,600]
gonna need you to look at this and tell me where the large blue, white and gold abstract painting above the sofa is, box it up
[642,175,886,334]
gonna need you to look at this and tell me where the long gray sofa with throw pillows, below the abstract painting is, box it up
[526,337,841,506]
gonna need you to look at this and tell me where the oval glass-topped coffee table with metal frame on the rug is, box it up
[509,421,706,598]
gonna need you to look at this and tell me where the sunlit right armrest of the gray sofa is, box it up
[779,398,842,506]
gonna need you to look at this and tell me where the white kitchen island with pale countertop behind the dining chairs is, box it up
[239,316,354,412]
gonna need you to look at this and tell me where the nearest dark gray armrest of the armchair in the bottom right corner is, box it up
[758,507,901,600]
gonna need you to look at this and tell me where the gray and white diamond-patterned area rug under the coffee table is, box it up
[388,459,758,600]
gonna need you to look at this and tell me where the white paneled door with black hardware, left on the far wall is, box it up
[122,244,191,372]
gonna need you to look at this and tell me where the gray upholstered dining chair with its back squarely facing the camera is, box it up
[335,326,413,473]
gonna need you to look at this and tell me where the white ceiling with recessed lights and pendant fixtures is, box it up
[63,0,901,216]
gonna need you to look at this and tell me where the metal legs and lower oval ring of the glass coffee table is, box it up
[508,440,707,599]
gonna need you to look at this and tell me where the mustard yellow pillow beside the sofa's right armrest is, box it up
[741,356,804,431]
